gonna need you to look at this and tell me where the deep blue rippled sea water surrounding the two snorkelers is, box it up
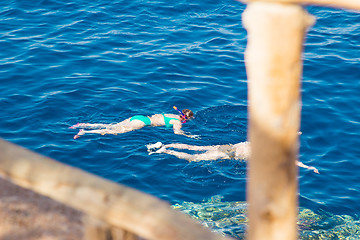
[0,0,360,231]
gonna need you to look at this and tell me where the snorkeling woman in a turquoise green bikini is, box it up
[70,106,198,139]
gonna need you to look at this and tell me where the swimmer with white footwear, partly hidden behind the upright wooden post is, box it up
[146,142,319,174]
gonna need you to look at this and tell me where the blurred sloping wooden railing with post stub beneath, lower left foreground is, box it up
[0,139,231,240]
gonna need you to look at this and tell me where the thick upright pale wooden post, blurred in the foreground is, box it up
[243,2,314,240]
